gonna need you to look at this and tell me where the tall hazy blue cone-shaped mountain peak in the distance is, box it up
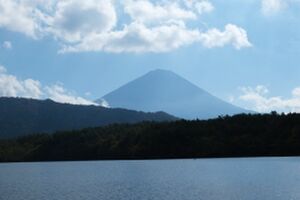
[96,70,249,119]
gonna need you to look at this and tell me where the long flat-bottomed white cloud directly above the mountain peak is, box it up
[63,23,199,53]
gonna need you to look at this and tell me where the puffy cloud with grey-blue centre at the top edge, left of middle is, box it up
[47,0,117,42]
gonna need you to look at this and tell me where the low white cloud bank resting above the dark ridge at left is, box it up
[0,66,95,105]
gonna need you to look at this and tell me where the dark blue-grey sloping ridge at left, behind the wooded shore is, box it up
[0,97,176,138]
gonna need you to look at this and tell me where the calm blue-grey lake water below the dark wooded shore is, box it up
[0,158,300,200]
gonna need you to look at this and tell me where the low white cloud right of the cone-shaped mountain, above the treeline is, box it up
[238,85,300,112]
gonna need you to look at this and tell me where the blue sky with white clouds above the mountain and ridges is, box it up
[0,0,300,112]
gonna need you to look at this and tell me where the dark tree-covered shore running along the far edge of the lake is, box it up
[0,113,300,162]
